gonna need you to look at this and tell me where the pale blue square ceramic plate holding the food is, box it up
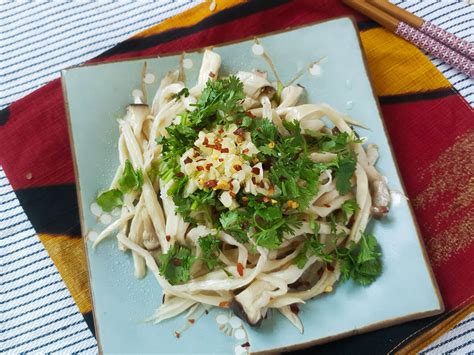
[63,18,443,354]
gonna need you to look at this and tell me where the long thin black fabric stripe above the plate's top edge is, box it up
[97,0,290,58]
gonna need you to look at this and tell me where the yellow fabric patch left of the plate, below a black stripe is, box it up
[39,234,92,313]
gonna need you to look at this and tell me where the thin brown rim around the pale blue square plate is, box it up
[61,15,445,355]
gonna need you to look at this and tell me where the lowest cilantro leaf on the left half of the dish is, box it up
[160,245,196,285]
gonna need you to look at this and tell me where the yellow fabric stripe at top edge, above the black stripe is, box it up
[132,0,246,38]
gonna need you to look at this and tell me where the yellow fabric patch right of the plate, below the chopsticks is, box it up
[360,28,451,96]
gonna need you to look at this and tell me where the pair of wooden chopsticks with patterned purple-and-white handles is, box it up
[343,0,474,78]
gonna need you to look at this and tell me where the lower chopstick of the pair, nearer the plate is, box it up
[342,0,474,78]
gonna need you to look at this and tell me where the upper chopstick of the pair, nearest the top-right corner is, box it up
[367,0,474,60]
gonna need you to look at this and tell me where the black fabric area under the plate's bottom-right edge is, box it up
[291,313,448,355]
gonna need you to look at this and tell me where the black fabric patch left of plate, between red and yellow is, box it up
[15,184,81,237]
